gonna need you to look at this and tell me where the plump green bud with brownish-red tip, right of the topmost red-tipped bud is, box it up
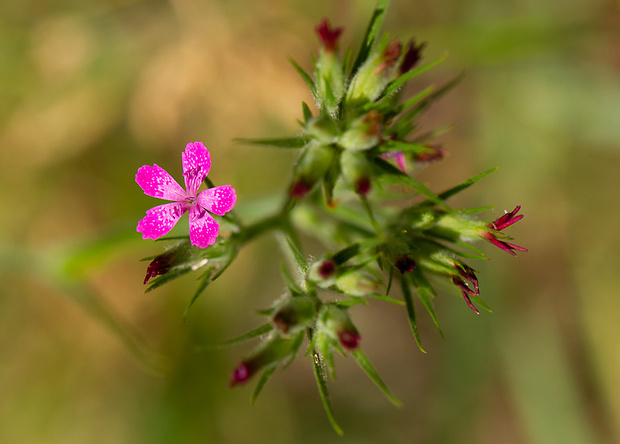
[345,40,402,106]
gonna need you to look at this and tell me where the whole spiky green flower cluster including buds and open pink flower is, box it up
[136,6,527,430]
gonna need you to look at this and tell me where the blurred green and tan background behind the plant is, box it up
[0,0,620,444]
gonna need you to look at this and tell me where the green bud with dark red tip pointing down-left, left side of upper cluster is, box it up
[289,142,334,198]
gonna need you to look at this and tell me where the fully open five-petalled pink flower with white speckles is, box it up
[136,142,237,248]
